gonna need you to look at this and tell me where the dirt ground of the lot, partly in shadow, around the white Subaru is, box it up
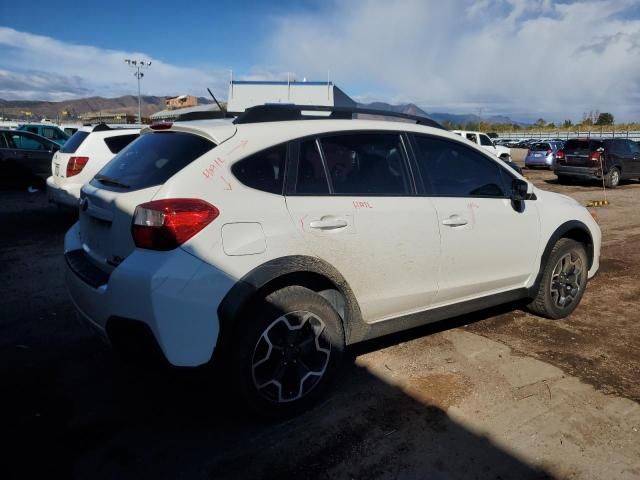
[0,148,640,479]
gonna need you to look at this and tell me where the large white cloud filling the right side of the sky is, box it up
[266,0,640,120]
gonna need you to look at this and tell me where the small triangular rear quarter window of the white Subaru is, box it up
[231,143,287,195]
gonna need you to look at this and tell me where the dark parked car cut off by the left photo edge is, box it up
[0,129,60,186]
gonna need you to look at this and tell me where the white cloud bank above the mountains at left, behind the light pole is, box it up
[0,27,229,100]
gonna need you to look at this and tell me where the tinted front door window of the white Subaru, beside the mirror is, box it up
[415,136,508,197]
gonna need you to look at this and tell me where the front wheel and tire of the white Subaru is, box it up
[527,238,588,320]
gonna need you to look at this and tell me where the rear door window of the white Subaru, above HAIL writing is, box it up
[320,133,411,195]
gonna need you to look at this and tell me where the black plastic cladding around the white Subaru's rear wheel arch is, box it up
[218,255,361,344]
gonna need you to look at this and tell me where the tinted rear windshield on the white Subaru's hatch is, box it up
[91,132,216,190]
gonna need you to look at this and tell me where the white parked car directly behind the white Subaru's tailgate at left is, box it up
[47,123,140,208]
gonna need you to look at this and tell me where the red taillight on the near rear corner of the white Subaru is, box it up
[131,198,220,250]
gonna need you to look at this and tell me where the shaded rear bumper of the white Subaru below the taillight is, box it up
[65,223,235,367]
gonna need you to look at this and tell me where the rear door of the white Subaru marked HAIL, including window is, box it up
[286,132,440,322]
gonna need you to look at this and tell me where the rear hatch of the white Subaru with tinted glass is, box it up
[79,131,216,272]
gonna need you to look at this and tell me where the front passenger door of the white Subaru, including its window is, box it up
[414,135,540,304]
